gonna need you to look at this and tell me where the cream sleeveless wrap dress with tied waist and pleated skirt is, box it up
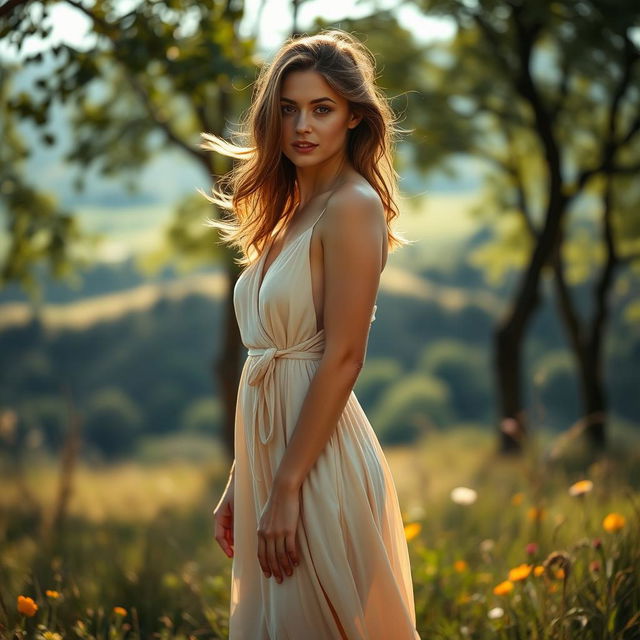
[229,207,420,640]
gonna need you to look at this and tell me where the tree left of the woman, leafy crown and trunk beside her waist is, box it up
[0,0,255,460]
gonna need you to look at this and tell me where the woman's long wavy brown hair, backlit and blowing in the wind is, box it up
[198,29,409,266]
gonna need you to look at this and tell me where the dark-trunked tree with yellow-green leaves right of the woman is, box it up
[404,0,640,452]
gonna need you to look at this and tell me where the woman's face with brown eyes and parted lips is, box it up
[280,70,361,167]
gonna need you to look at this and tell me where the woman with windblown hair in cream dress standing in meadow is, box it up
[201,29,419,640]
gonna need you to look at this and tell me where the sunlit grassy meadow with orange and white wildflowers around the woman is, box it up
[0,425,640,640]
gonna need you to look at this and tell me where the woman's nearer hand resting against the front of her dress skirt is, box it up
[258,485,300,583]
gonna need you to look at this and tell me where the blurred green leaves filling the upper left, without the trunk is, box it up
[0,0,256,296]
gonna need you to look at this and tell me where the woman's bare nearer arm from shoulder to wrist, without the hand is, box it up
[274,189,387,491]
